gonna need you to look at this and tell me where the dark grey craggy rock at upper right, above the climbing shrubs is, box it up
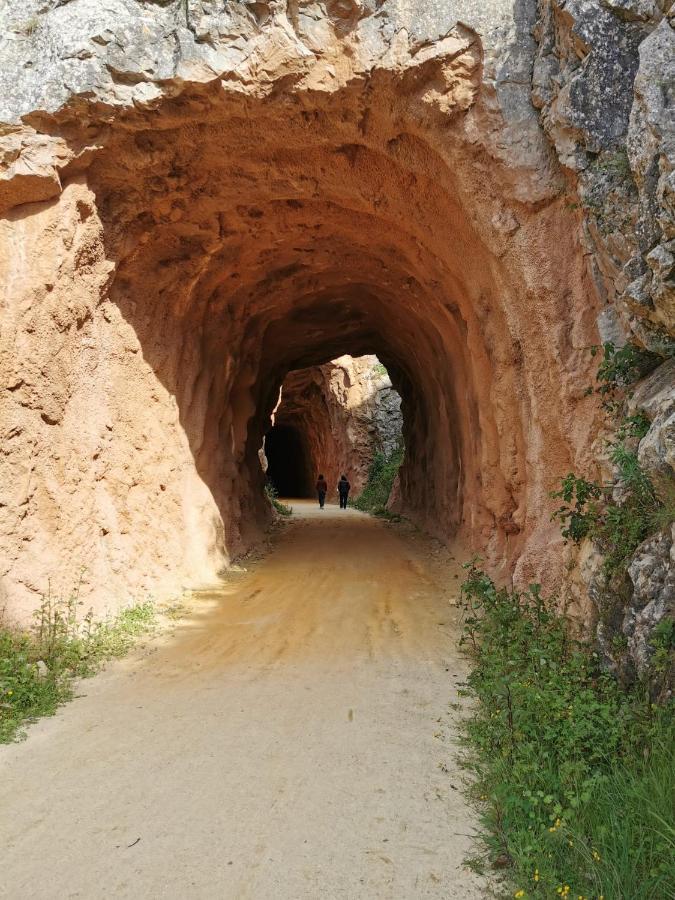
[532,0,675,353]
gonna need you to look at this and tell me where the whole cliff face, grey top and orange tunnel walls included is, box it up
[0,0,675,614]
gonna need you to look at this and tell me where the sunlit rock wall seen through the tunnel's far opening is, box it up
[266,355,403,499]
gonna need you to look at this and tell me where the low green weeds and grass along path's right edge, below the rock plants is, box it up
[462,562,675,900]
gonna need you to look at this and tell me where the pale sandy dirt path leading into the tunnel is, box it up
[0,504,485,900]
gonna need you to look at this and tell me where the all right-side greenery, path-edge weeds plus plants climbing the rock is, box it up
[462,344,675,900]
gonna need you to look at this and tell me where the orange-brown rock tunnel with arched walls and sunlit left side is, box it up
[2,14,597,624]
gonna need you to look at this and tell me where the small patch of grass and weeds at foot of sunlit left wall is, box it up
[0,592,155,743]
